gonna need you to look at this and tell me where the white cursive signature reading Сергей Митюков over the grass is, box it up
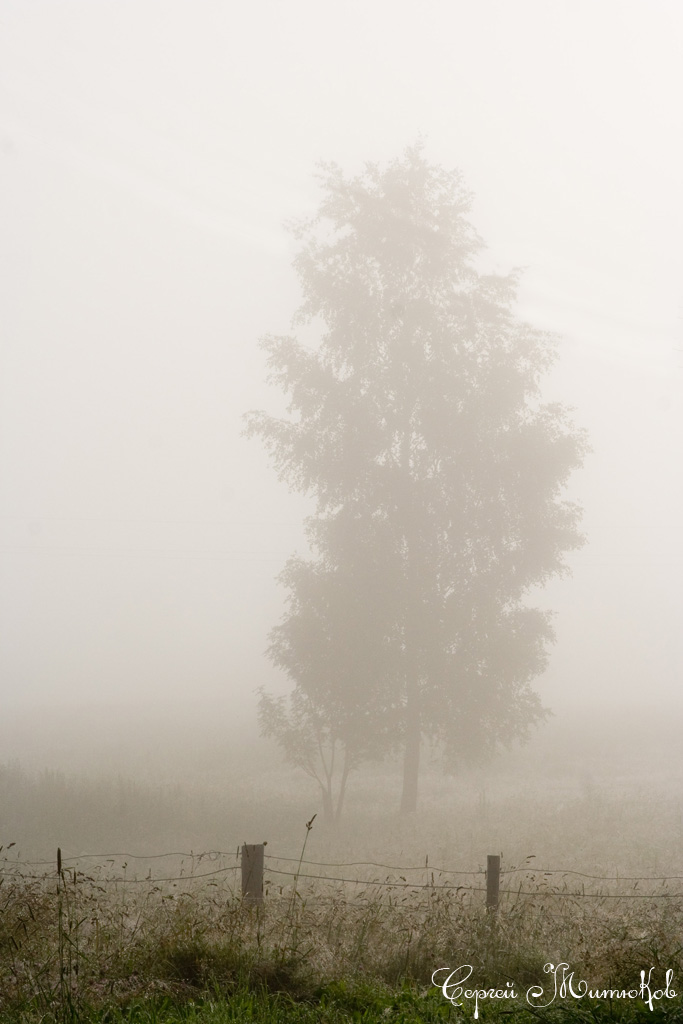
[432,963,677,1020]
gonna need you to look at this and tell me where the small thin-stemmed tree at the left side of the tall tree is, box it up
[259,558,401,822]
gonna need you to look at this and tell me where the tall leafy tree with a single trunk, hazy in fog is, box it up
[248,146,587,811]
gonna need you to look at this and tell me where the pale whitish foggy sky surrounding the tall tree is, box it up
[0,0,683,729]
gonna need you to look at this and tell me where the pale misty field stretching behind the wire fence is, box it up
[0,710,683,883]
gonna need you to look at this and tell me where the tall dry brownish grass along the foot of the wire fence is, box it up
[0,851,683,1024]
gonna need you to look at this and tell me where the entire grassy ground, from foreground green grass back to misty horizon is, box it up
[0,704,683,1024]
